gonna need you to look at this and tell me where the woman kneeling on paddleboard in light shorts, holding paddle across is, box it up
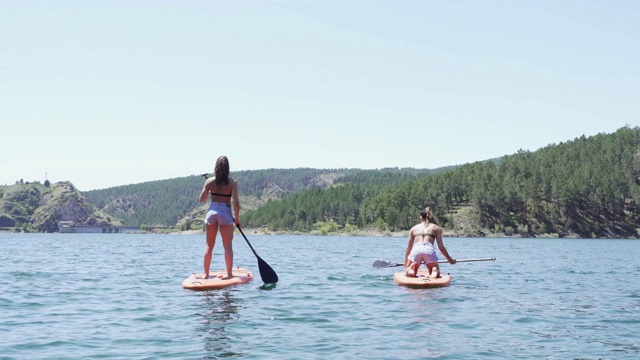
[404,207,456,278]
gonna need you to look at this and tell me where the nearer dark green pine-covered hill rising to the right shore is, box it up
[243,127,640,238]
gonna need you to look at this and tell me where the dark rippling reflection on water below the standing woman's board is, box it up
[196,289,244,359]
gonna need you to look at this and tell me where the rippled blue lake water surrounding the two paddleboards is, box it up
[0,233,640,359]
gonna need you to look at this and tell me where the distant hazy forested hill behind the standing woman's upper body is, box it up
[84,168,447,227]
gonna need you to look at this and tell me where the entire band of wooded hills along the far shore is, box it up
[0,126,640,238]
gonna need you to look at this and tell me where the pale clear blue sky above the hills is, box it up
[0,0,640,191]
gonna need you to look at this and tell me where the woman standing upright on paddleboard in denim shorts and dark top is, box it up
[200,155,240,279]
